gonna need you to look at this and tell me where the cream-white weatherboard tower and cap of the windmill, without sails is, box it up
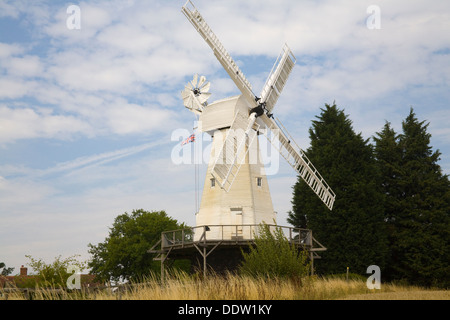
[195,96,276,240]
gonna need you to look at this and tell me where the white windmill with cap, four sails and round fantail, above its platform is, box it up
[181,0,335,239]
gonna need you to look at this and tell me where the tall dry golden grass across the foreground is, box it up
[0,275,450,300]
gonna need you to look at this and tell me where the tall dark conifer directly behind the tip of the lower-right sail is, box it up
[288,104,387,274]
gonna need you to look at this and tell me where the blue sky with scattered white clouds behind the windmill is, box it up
[0,0,450,272]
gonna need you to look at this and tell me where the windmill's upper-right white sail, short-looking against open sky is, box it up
[261,44,296,113]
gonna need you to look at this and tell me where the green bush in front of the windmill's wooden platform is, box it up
[240,224,309,279]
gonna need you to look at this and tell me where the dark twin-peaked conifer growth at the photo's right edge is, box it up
[375,108,450,287]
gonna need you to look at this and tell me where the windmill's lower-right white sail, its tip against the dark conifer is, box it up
[262,116,336,210]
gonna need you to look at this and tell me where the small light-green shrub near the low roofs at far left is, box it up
[24,255,86,288]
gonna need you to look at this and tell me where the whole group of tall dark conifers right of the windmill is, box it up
[288,105,450,288]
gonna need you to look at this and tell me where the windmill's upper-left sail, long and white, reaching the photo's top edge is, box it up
[181,0,256,106]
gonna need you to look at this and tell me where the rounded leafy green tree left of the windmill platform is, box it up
[88,209,185,281]
